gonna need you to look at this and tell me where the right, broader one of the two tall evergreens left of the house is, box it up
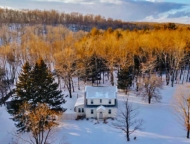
[31,59,64,109]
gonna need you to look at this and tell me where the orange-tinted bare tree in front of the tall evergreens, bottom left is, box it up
[17,103,61,144]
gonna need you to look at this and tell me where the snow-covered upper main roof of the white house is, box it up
[85,86,117,99]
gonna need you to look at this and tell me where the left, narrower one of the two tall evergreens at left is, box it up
[7,62,33,132]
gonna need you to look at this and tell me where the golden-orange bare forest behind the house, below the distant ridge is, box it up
[0,22,190,103]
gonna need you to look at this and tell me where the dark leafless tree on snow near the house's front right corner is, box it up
[113,99,144,141]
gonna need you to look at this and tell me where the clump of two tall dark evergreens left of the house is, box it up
[8,59,64,132]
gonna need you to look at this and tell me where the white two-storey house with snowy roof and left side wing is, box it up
[75,86,117,119]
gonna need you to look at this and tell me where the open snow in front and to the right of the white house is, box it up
[53,86,190,144]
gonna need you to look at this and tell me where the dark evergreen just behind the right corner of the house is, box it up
[117,67,133,92]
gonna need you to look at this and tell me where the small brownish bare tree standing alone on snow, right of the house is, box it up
[137,75,163,104]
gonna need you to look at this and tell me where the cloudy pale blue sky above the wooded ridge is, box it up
[0,0,190,24]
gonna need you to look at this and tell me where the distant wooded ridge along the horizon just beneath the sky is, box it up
[0,8,190,31]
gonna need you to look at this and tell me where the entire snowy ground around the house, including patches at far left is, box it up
[0,75,190,144]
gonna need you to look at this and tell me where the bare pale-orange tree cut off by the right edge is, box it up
[172,84,190,138]
